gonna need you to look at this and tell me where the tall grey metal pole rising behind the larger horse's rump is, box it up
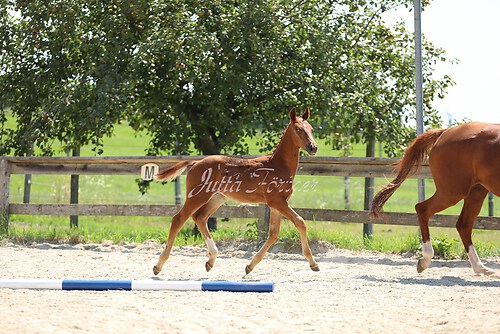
[413,0,425,202]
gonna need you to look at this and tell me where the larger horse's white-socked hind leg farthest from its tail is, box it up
[456,184,495,275]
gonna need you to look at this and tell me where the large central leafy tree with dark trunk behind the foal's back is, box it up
[129,1,316,154]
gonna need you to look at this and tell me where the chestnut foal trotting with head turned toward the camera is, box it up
[153,108,319,275]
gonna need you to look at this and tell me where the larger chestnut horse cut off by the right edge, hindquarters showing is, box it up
[371,123,500,275]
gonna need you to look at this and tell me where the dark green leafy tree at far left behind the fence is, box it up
[0,0,145,155]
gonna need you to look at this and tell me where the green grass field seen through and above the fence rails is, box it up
[4,120,500,256]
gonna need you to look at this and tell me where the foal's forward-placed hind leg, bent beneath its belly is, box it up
[193,193,227,271]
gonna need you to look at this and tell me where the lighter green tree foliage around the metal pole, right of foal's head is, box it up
[320,2,453,156]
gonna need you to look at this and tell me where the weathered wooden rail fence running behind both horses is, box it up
[0,156,500,235]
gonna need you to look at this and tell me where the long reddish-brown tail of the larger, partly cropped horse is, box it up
[370,129,446,218]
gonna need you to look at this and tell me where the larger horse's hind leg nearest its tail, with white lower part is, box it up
[415,191,460,273]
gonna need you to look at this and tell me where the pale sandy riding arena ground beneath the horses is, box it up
[0,242,500,334]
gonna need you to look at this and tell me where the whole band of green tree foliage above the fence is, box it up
[0,0,452,155]
